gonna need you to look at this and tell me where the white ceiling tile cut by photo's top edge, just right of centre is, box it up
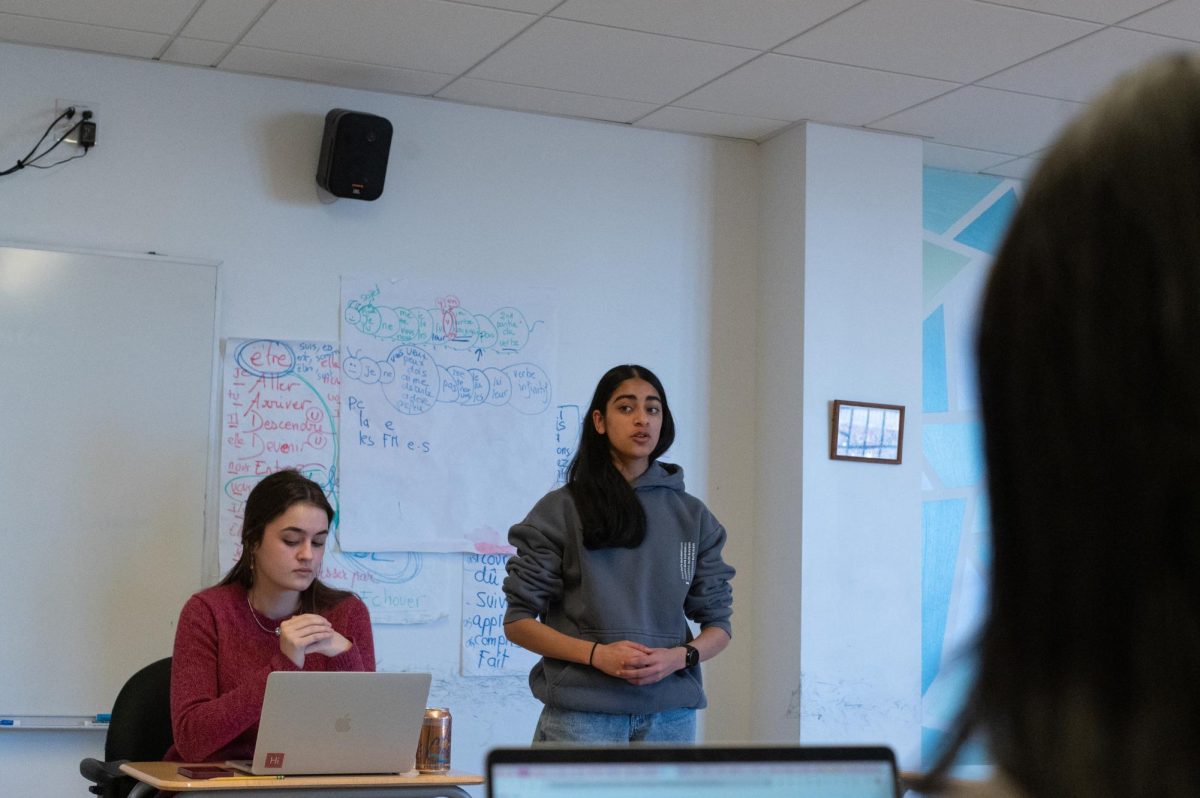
[552,0,859,49]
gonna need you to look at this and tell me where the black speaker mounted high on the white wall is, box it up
[317,108,391,199]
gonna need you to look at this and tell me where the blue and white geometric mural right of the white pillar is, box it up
[920,169,1020,767]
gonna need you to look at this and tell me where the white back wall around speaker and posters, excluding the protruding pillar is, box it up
[0,44,758,794]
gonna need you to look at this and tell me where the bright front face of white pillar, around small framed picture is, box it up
[800,126,922,762]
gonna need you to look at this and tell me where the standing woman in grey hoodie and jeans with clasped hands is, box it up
[504,366,733,743]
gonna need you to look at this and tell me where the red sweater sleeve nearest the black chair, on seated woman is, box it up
[170,596,296,762]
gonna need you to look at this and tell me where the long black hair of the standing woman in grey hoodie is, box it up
[566,365,674,548]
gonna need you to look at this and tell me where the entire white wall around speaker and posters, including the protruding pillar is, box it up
[0,35,920,794]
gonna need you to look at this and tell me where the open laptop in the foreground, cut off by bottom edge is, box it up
[487,745,900,798]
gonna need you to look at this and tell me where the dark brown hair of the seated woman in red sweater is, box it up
[220,469,353,612]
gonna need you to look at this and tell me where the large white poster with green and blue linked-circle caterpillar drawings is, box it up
[340,278,557,553]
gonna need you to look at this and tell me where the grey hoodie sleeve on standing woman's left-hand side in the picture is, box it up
[504,494,566,624]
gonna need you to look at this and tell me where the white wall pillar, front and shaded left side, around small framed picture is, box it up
[754,124,922,763]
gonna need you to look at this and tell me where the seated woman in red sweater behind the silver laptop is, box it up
[164,470,374,762]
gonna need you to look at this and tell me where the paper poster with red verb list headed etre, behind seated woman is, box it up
[217,338,457,623]
